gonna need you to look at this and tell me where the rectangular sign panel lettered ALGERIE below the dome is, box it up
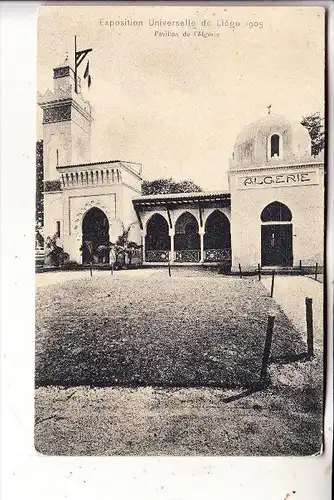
[238,171,319,189]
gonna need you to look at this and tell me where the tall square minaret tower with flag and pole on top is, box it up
[38,38,92,239]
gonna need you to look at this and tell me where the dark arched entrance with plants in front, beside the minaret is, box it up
[82,207,109,264]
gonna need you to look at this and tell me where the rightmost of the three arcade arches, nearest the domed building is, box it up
[204,210,231,262]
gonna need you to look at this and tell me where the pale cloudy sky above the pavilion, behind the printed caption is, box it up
[37,5,324,190]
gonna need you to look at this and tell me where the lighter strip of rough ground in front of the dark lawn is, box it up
[35,387,321,456]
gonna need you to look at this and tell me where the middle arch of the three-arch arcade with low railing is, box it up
[174,212,200,262]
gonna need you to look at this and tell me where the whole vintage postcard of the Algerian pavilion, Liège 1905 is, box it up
[35,4,326,456]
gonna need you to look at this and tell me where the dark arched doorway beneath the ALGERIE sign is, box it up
[261,201,293,266]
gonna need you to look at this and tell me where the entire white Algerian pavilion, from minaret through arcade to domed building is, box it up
[39,63,324,271]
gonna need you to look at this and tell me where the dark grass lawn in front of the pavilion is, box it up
[36,271,306,388]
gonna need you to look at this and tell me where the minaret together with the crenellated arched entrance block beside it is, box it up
[38,62,142,264]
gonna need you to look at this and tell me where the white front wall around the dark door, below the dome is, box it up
[230,166,324,269]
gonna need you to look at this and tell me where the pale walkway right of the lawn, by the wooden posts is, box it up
[262,276,324,350]
